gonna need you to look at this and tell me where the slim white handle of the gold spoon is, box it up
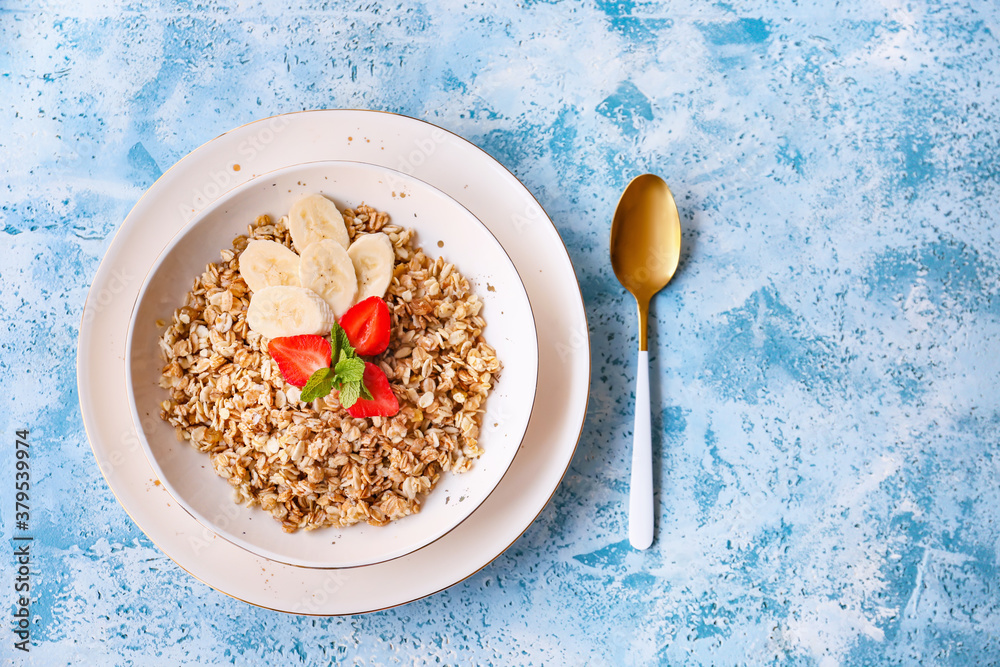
[628,350,653,549]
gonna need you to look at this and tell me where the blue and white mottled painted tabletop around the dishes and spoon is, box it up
[0,0,1000,666]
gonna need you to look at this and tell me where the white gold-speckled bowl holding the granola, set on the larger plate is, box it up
[126,161,538,568]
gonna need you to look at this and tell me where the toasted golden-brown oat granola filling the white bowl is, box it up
[160,206,501,532]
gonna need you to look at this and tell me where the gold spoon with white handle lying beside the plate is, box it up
[611,174,681,549]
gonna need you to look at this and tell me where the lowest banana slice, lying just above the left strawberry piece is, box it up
[247,285,336,338]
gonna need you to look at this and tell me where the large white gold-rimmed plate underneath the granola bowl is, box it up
[77,111,590,615]
